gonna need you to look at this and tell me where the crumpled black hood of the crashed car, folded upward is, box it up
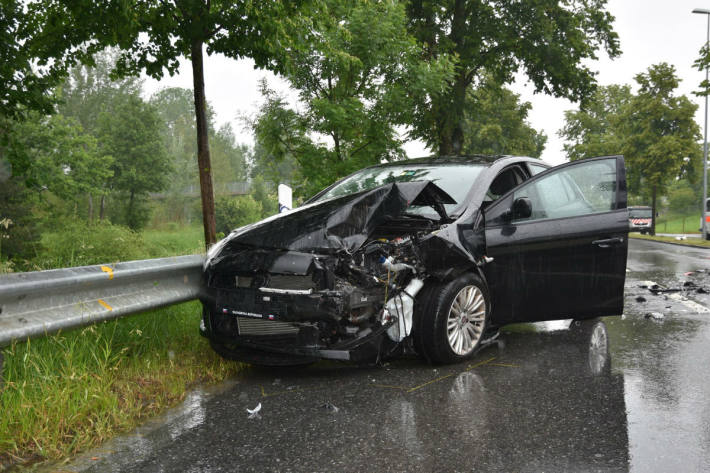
[215,181,456,256]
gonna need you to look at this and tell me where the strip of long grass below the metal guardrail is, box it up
[0,302,240,470]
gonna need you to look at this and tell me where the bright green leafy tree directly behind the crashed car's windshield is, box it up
[253,0,450,194]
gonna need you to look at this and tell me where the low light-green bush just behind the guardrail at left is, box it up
[35,220,149,269]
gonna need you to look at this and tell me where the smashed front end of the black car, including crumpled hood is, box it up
[202,181,474,364]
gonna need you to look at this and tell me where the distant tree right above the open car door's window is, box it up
[558,85,633,161]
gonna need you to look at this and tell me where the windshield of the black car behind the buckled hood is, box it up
[316,164,485,214]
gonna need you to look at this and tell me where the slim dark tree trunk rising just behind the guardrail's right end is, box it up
[191,40,217,248]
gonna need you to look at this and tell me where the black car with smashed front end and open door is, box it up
[201,156,629,365]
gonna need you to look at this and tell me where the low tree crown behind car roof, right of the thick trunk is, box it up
[462,82,547,158]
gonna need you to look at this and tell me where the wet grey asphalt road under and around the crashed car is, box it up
[57,241,710,472]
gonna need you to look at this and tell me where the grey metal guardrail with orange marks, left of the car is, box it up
[0,255,204,346]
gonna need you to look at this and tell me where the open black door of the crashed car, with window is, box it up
[484,156,629,325]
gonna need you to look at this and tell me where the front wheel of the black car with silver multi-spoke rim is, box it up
[415,274,490,363]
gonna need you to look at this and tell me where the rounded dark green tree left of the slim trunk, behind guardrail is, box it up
[98,95,171,230]
